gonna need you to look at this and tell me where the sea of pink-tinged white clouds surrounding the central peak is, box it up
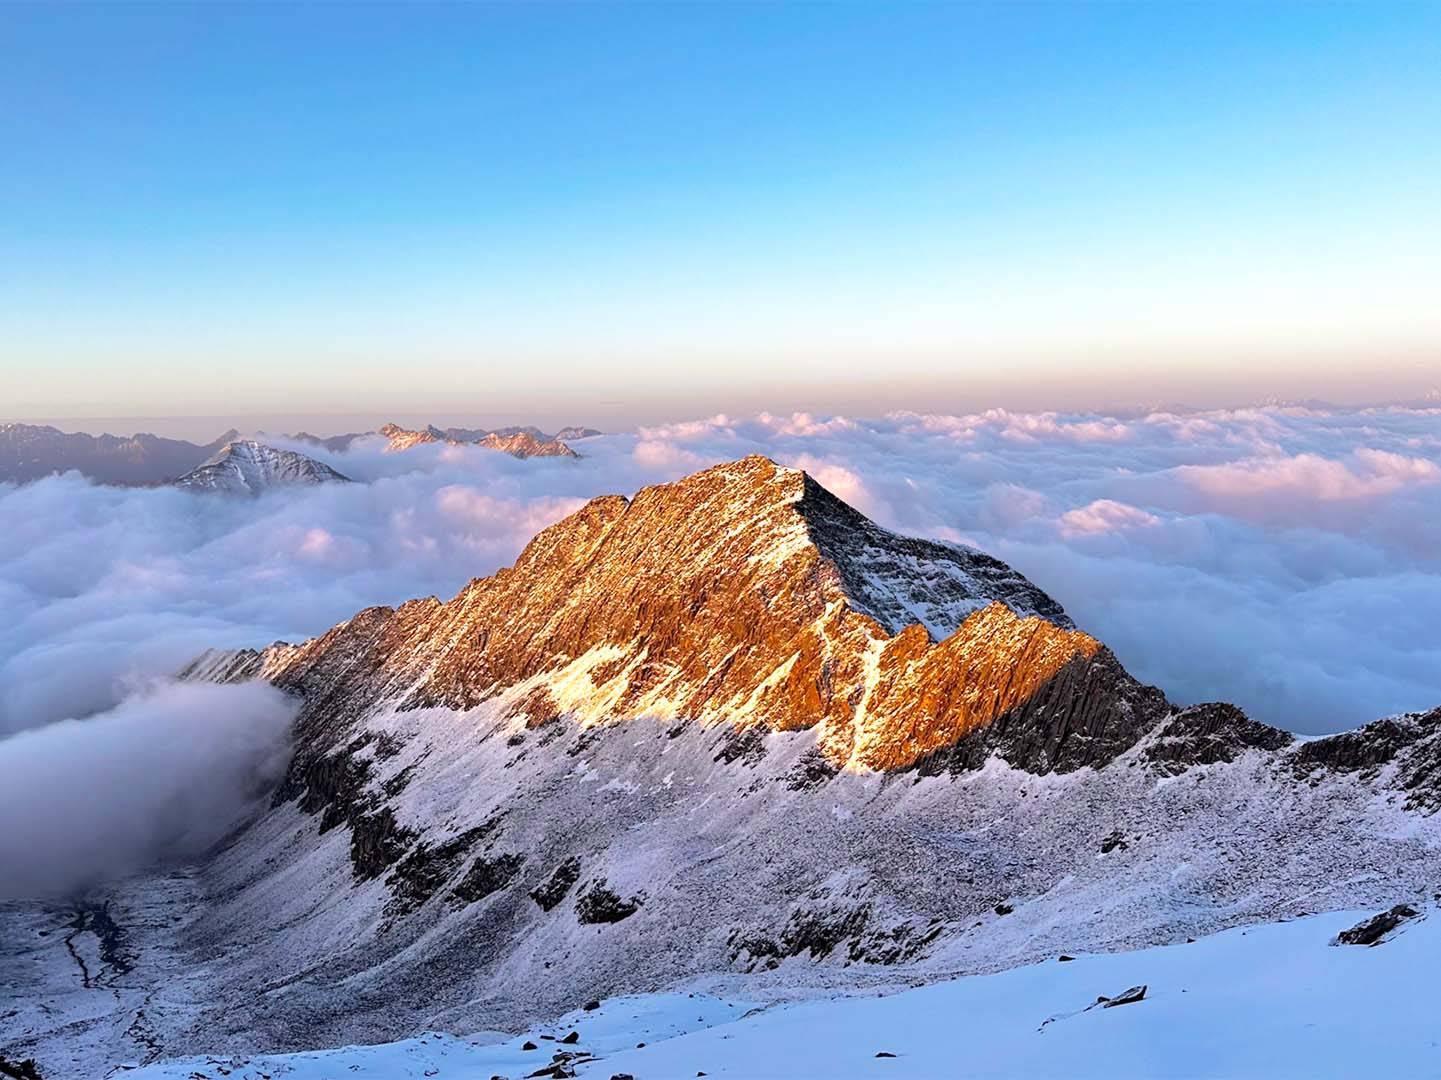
[0,408,1441,893]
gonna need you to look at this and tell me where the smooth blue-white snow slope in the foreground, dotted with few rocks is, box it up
[127,911,1441,1080]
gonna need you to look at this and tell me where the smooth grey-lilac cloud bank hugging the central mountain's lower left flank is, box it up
[0,682,295,900]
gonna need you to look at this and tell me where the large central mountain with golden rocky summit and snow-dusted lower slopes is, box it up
[0,457,1441,1077]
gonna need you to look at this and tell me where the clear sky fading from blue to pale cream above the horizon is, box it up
[0,3,1441,425]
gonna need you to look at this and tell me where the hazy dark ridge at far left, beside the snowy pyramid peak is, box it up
[0,424,239,484]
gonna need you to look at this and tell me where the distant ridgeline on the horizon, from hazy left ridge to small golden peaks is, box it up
[0,424,601,486]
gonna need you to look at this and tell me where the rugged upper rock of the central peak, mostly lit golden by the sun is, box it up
[188,457,1147,783]
